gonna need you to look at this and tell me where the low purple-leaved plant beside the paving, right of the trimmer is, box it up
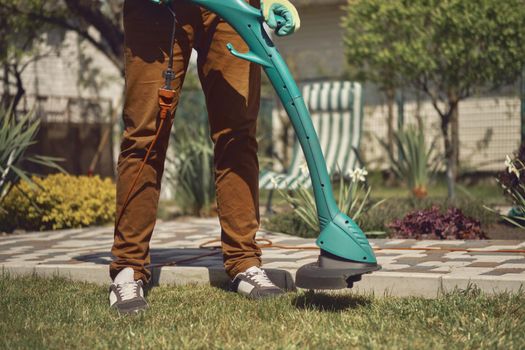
[388,206,486,239]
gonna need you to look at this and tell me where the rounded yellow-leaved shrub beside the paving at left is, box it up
[0,174,115,232]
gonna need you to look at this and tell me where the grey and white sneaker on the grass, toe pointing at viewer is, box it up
[109,267,148,314]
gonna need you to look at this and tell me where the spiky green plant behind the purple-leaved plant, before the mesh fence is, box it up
[379,126,441,198]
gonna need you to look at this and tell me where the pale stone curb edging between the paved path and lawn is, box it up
[0,263,525,298]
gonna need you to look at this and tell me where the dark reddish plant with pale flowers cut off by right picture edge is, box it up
[498,142,525,227]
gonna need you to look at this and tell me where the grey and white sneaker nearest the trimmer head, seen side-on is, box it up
[232,266,284,299]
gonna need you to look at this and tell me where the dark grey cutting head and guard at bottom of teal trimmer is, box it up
[295,249,381,289]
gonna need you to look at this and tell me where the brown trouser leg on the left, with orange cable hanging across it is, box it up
[110,0,200,282]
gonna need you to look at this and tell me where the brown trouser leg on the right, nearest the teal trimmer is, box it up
[195,3,261,278]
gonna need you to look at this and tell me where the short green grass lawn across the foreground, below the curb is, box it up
[0,275,525,349]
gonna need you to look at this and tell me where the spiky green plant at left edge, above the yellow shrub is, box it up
[0,106,64,203]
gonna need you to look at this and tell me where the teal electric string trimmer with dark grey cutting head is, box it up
[191,0,380,289]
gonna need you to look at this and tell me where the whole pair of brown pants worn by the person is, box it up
[110,0,261,281]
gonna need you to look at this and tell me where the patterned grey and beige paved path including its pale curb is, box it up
[0,218,525,297]
